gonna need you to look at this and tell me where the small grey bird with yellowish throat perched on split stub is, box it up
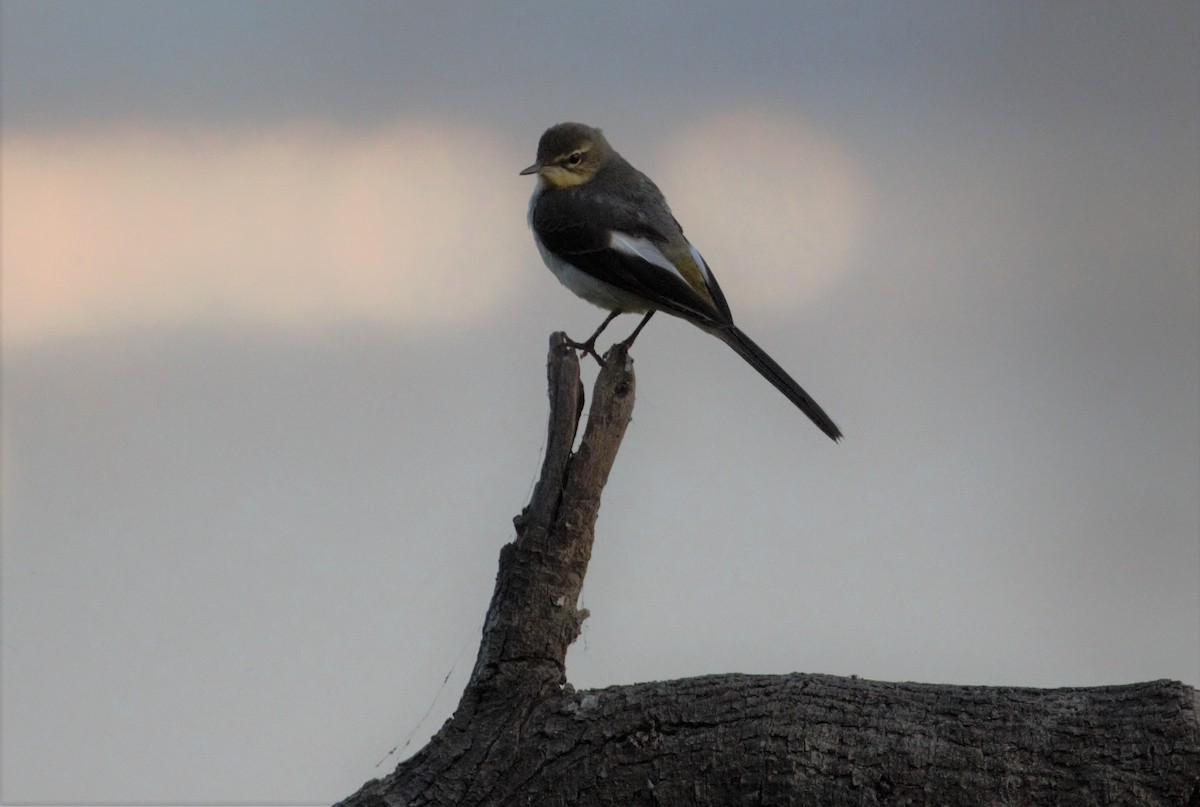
[520,122,842,442]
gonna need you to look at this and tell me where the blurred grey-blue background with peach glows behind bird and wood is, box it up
[0,0,1200,805]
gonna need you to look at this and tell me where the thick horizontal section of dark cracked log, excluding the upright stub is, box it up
[458,674,1196,807]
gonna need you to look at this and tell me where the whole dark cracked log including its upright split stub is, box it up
[340,334,1200,807]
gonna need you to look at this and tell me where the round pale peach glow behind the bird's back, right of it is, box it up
[662,110,870,315]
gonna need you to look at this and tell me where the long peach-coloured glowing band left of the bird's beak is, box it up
[0,121,529,341]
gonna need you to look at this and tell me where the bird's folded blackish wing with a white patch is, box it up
[532,192,732,328]
